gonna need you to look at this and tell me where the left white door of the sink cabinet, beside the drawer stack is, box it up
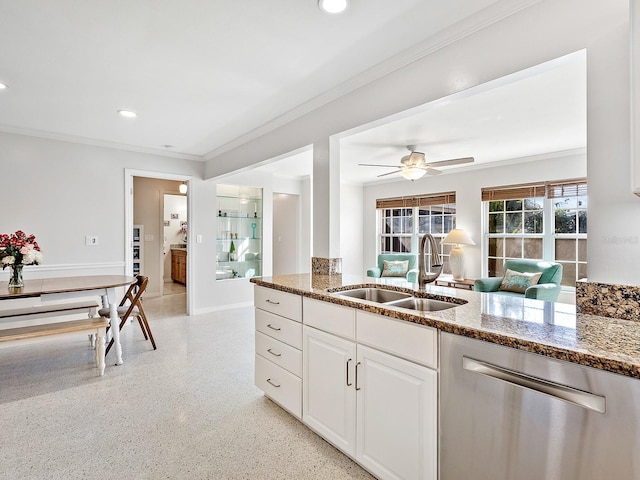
[302,326,356,456]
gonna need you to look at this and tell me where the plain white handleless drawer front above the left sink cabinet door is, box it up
[303,297,356,340]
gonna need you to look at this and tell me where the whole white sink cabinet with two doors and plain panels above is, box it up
[302,298,437,480]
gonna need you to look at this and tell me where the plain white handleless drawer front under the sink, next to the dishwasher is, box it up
[356,311,438,368]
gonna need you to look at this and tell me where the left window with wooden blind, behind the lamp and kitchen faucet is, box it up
[376,192,456,272]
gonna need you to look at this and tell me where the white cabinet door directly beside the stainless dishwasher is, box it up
[356,345,437,480]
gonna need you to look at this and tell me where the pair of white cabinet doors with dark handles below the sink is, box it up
[302,320,437,480]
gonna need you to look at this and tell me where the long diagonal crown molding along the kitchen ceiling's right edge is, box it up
[203,0,542,160]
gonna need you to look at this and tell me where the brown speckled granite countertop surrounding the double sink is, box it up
[251,274,640,378]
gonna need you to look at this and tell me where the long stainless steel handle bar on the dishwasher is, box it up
[462,356,606,413]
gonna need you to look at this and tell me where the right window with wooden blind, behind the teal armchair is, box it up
[482,179,587,286]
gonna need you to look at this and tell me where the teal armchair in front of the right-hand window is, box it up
[473,259,562,302]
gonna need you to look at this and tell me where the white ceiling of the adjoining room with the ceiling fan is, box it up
[254,51,587,184]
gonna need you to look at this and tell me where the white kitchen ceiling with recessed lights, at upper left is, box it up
[0,0,510,160]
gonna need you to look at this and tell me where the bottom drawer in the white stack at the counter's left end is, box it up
[255,355,302,418]
